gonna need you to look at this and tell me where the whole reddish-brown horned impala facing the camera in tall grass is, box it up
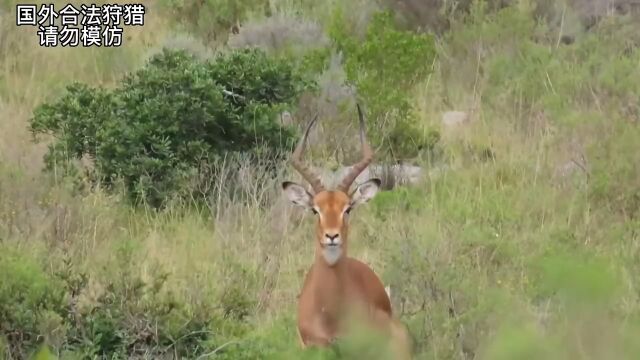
[282,105,410,359]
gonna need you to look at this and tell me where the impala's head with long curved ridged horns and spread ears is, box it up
[282,105,381,266]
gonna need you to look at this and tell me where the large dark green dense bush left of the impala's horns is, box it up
[31,49,311,207]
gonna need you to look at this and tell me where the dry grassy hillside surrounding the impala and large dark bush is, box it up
[0,0,640,359]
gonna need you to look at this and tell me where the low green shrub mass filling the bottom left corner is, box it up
[0,242,254,359]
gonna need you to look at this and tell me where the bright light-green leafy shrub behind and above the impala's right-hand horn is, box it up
[330,11,438,159]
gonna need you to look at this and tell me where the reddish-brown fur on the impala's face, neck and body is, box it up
[298,191,410,359]
